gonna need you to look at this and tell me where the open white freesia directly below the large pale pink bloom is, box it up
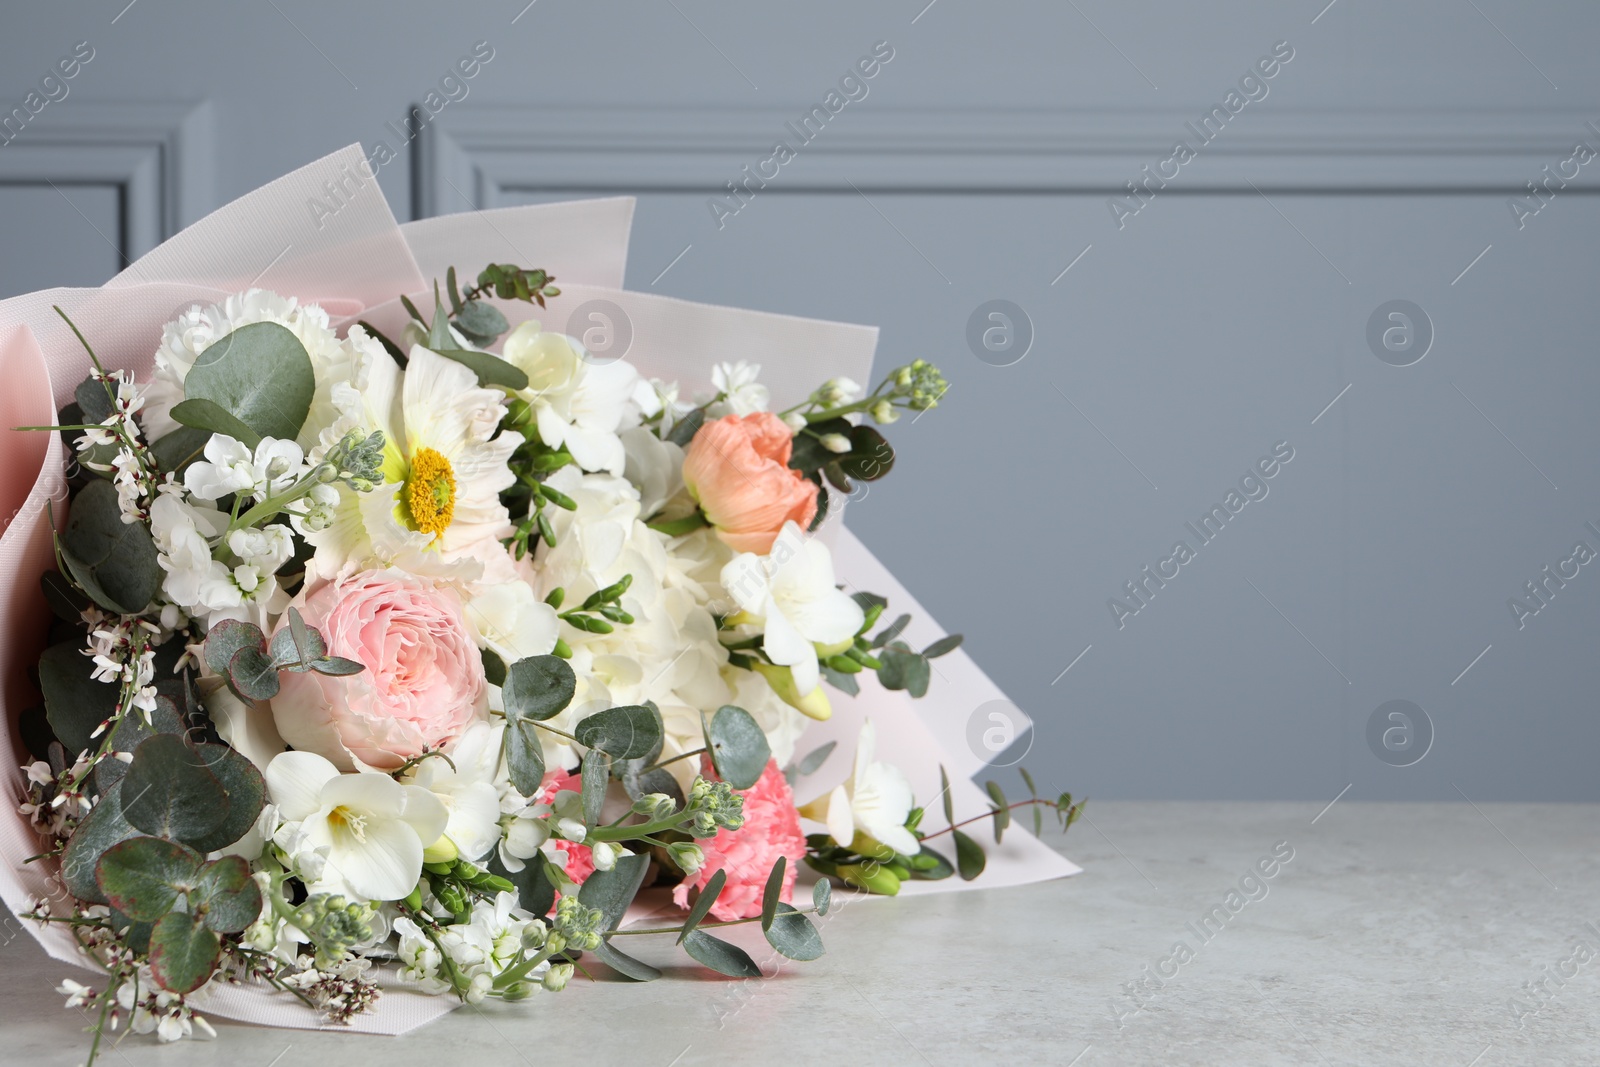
[266,752,450,901]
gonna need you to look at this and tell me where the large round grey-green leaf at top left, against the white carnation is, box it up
[184,322,317,440]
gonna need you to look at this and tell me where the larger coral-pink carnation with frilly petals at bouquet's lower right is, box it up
[672,760,805,921]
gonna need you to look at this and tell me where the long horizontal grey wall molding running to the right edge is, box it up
[413,102,1600,218]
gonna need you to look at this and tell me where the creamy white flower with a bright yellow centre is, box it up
[309,347,522,581]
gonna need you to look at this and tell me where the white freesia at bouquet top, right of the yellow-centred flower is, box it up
[502,320,638,475]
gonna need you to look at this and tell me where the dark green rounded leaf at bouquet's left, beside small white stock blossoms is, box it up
[59,480,162,614]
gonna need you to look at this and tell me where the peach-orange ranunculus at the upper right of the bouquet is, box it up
[683,411,816,555]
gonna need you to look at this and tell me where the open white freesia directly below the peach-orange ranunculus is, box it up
[722,522,862,696]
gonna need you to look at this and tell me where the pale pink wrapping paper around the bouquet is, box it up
[0,146,1078,1035]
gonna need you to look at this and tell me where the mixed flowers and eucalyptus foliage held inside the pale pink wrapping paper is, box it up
[6,147,1078,1057]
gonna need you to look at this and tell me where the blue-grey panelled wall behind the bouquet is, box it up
[0,0,1600,800]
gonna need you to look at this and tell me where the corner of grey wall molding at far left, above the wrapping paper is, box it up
[0,98,216,264]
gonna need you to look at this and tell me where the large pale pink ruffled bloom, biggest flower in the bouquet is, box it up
[272,569,488,771]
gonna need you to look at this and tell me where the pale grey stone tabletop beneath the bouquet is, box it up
[0,801,1600,1067]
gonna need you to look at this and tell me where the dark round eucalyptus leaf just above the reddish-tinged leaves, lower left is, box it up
[122,734,229,844]
